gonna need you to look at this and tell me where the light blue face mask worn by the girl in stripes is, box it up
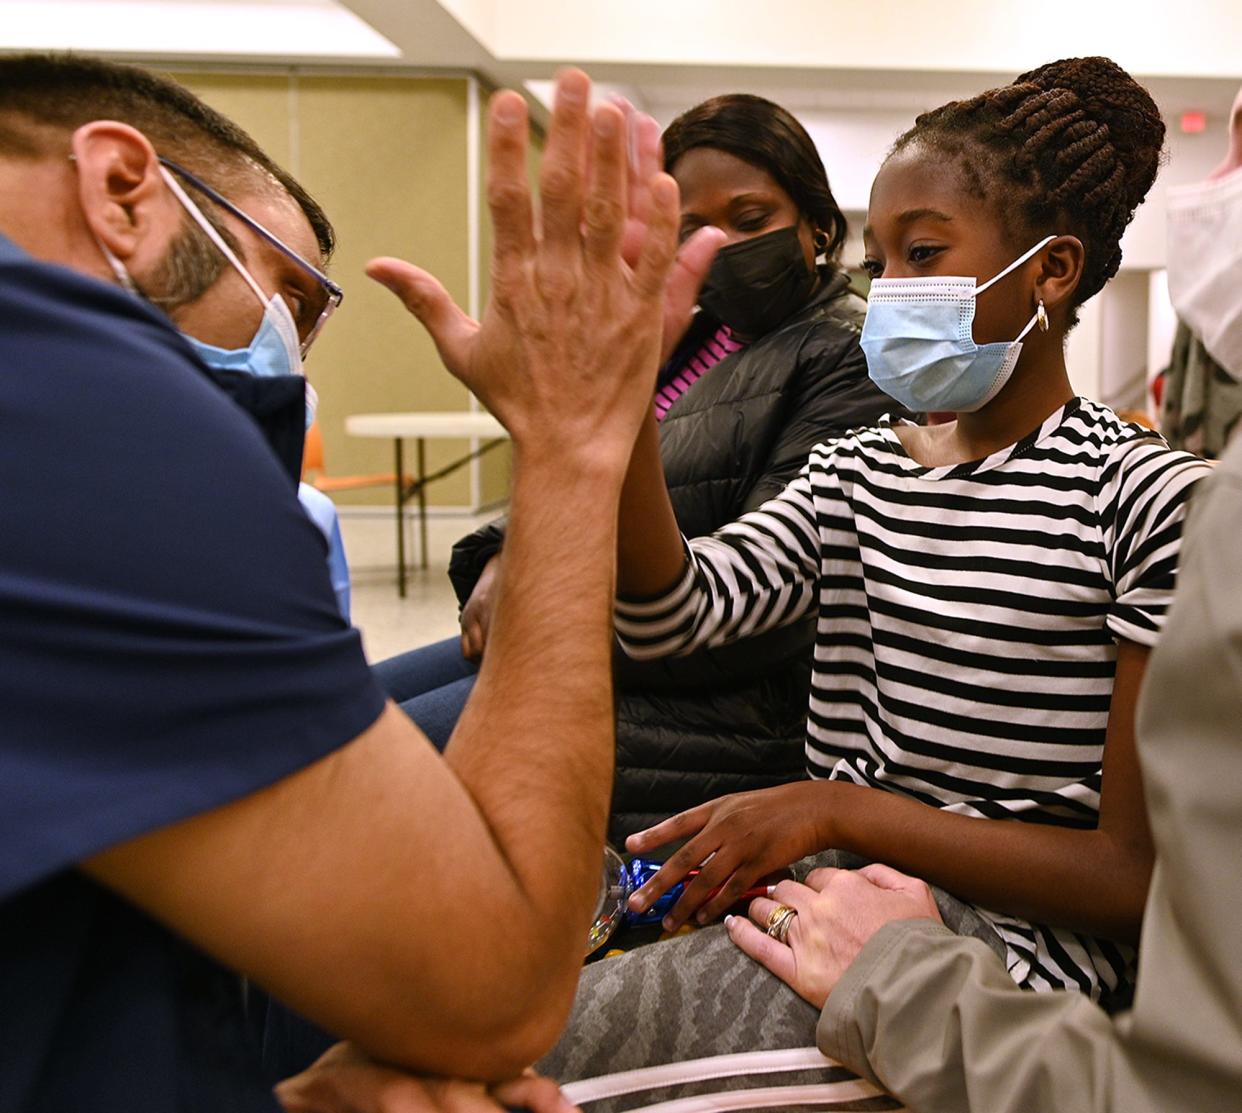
[862,236,1056,414]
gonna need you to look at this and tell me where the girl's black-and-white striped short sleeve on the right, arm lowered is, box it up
[1102,441,1211,647]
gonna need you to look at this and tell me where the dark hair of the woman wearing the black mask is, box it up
[663,93,848,260]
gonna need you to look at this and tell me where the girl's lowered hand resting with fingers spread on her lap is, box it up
[626,781,833,932]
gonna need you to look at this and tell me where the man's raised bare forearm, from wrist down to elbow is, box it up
[445,451,621,958]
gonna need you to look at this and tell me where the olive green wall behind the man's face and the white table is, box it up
[175,72,489,507]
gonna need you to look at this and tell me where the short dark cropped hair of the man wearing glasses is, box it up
[0,53,337,260]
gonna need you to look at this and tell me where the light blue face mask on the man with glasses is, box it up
[99,166,319,429]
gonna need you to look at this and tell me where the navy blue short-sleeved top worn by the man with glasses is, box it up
[0,237,384,1113]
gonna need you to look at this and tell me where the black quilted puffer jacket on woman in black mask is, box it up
[448,272,897,842]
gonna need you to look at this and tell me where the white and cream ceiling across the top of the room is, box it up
[0,0,1242,119]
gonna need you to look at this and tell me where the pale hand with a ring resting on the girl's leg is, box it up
[725,866,940,1009]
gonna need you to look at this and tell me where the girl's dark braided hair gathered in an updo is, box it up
[893,57,1165,323]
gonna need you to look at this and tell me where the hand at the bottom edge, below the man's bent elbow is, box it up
[276,1043,576,1113]
